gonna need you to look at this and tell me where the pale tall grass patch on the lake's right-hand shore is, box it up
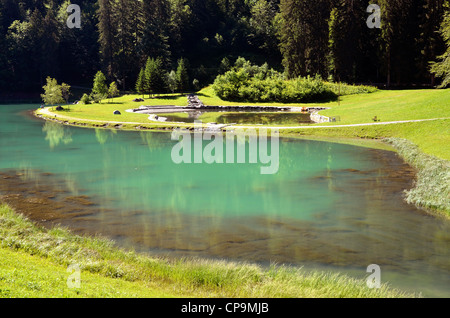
[386,138,450,216]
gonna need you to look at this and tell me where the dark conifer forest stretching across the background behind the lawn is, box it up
[0,0,450,96]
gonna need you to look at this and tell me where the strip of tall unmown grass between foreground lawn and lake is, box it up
[0,205,414,298]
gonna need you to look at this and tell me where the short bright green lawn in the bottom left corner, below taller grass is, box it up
[0,248,186,298]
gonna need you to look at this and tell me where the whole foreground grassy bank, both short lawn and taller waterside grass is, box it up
[0,205,414,298]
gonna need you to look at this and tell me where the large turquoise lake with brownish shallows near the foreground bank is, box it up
[0,105,450,297]
